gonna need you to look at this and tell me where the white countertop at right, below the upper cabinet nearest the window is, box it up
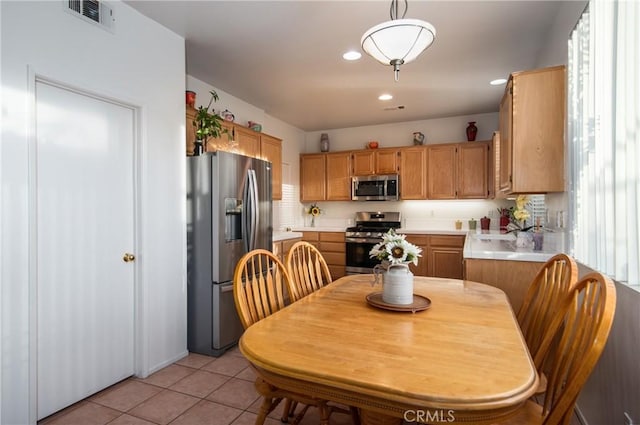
[463,230,564,263]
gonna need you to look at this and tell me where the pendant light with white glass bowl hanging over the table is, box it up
[361,0,436,81]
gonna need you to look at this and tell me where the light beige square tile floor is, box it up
[38,348,579,425]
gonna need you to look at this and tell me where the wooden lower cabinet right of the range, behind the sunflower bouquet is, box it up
[407,235,465,279]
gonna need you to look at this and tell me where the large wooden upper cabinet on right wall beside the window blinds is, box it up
[500,66,566,193]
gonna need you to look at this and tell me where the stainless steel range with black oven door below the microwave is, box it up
[345,211,400,274]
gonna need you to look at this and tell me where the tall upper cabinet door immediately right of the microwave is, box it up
[400,147,427,199]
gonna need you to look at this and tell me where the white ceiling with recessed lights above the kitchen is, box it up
[127,0,585,131]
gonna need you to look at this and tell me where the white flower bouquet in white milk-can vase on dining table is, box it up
[369,229,422,305]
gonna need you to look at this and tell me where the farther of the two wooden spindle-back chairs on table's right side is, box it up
[518,254,578,394]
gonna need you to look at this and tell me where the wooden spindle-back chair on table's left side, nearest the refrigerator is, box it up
[233,249,355,425]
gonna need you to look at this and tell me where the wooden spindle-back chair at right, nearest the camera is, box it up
[490,273,616,425]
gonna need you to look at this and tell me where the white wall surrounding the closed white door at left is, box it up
[0,1,186,424]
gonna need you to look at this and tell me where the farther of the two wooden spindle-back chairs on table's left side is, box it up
[286,241,332,301]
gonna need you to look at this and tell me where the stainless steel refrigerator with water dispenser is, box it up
[187,152,273,356]
